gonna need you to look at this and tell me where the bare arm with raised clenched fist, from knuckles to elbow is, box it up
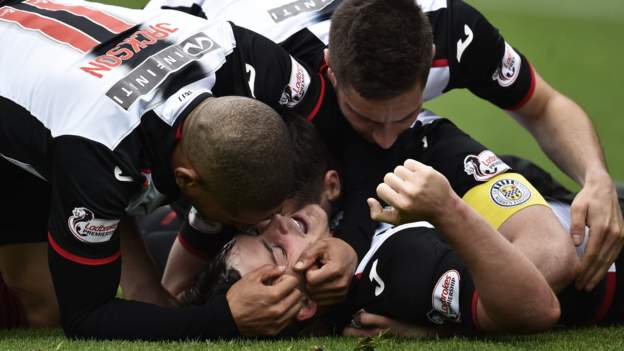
[368,160,560,332]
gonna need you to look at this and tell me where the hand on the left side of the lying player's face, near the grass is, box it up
[226,265,304,336]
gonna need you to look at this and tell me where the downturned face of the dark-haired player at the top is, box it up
[337,84,423,149]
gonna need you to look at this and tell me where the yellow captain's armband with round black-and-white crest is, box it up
[463,173,548,229]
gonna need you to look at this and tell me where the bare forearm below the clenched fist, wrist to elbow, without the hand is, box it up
[434,196,560,331]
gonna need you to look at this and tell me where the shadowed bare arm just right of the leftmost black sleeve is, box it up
[119,217,176,307]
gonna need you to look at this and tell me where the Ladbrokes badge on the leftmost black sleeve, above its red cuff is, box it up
[67,207,119,244]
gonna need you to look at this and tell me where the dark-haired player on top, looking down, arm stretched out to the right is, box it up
[146,0,624,290]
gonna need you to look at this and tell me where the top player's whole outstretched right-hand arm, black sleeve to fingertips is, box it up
[451,1,624,289]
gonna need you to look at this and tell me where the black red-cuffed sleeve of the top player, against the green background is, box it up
[449,0,535,110]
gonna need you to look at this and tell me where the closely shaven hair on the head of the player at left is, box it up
[182,96,294,213]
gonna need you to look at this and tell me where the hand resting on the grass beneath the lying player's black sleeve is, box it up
[342,310,437,338]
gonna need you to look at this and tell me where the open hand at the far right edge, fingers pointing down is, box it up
[570,174,624,291]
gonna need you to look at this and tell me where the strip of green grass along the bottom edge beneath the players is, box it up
[0,328,624,351]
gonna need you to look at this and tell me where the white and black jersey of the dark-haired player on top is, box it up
[146,0,535,110]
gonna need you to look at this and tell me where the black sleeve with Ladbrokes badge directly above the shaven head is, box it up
[214,25,321,117]
